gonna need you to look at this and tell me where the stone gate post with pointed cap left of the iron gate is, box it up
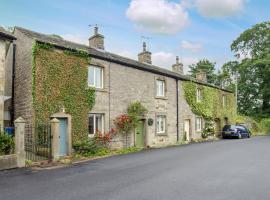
[14,117,26,167]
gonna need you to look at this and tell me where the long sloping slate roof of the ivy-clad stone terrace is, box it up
[15,27,232,92]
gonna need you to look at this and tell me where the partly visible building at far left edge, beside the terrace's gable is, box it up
[0,27,16,130]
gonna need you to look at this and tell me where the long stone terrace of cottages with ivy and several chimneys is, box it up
[10,27,236,148]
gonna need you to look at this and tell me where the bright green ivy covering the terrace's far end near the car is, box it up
[183,81,236,123]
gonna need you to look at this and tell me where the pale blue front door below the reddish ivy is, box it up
[58,118,67,156]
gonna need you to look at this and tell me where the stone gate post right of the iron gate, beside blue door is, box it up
[51,118,60,161]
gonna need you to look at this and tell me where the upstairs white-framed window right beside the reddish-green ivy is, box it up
[88,65,103,88]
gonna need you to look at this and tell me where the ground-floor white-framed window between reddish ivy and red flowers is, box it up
[88,114,104,135]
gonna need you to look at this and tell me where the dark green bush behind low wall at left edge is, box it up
[0,133,15,155]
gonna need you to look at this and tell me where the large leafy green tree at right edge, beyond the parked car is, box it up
[225,22,270,117]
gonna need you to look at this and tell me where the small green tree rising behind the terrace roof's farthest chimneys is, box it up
[189,59,218,84]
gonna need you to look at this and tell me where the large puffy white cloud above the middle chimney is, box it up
[126,0,188,34]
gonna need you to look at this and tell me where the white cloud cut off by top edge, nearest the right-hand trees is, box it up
[195,0,246,18]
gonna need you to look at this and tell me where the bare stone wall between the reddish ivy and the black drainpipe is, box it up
[91,59,177,147]
